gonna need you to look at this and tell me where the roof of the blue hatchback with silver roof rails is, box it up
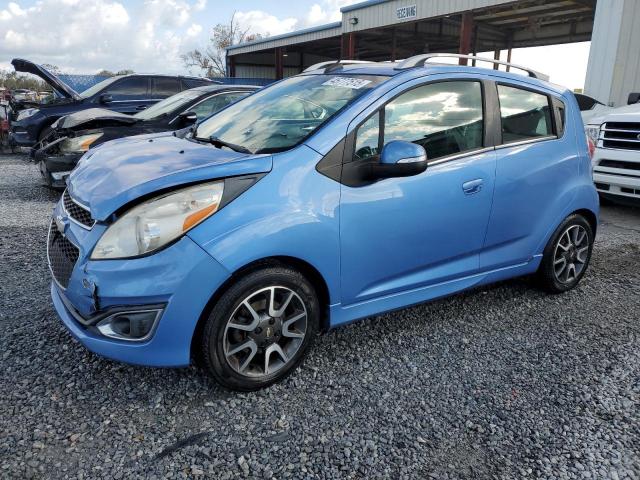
[303,62,568,95]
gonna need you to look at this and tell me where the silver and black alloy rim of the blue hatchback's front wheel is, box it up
[223,286,307,378]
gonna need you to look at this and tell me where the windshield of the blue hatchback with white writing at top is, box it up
[194,75,387,153]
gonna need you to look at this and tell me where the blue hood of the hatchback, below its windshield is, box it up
[68,133,272,221]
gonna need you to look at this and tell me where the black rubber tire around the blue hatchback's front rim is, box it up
[199,266,320,391]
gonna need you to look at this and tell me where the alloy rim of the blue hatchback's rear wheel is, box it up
[553,225,590,284]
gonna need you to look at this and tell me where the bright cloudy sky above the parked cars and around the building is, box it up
[0,0,589,89]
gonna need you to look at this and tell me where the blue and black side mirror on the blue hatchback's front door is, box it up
[369,140,428,180]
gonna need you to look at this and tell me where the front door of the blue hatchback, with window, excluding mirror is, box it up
[340,80,495,306]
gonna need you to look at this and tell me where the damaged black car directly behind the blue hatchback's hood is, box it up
[32,85,259,189]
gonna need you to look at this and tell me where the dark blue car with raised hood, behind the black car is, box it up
[9,58,217,147]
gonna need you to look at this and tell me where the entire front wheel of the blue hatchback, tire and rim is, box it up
[201,267,320,391]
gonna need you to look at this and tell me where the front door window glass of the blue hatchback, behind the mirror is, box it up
[356,81,483,160]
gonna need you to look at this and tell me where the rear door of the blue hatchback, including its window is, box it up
[480,83,579,270]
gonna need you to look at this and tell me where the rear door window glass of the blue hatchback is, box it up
[498,85,554,143]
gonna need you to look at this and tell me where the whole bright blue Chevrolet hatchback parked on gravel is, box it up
[48,55,598,390]
